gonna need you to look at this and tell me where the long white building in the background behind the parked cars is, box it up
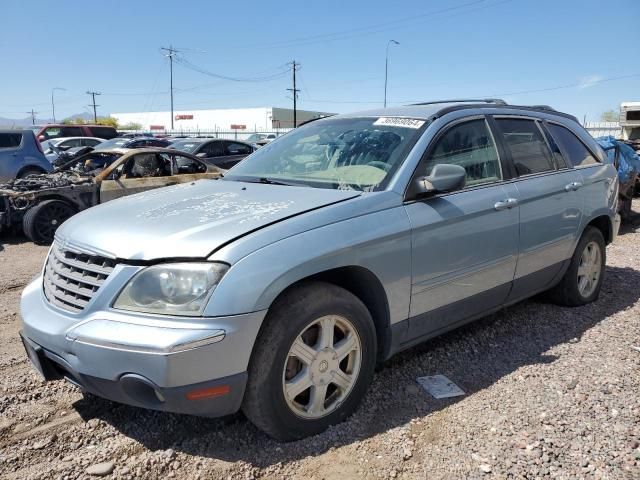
[111,107,333,133]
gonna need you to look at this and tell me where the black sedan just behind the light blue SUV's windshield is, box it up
[169,138,256,169]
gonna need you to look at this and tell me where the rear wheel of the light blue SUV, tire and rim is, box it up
[549,227,606,307]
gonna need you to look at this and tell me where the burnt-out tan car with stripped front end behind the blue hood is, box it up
[0,148,221,245]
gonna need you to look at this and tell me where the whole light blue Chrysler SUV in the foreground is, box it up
[21,100,619,441]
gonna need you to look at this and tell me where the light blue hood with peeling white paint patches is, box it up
[56,180,360,260]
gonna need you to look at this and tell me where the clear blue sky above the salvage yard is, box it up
[0,0,640,120]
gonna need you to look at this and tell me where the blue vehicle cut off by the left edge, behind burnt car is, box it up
[0,130,52,180]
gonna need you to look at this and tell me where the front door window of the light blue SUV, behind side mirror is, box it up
[425,120,502,185]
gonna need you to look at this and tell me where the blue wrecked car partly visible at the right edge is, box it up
[596,137,640,220]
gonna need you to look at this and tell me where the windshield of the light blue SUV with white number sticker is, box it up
[224,117,426,191]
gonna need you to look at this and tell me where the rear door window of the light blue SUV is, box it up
[496,118,555,176]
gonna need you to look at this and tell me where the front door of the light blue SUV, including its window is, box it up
[406,117,518,338]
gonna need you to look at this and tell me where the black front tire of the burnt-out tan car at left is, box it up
[22,200,76,245]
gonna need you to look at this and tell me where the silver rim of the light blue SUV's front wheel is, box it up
[282,315,362,419]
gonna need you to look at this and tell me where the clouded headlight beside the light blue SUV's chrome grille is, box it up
[113,263,229,317]
